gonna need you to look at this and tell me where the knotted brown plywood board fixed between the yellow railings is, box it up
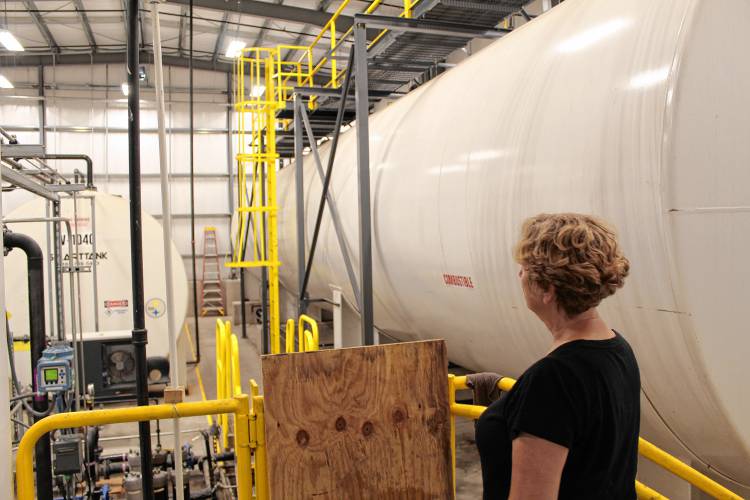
[263,340,453,500]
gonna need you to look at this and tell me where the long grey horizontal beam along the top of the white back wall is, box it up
[0,51,233,73]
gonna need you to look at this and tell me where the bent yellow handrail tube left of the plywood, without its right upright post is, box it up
[16,399,242,500]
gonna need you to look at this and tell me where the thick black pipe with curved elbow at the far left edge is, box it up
[3,232,52,500]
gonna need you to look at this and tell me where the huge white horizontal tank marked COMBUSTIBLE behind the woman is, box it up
[280,0,750,485]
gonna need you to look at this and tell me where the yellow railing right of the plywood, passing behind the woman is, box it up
[448,375,742,500]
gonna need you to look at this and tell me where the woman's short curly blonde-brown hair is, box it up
[514,213,630,317]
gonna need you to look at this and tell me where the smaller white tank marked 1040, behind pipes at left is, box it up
[5,191,188,360]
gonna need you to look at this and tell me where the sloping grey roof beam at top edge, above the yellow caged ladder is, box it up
[167,0,354,32]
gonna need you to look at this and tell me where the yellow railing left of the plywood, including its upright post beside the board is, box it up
[16,394,256,500]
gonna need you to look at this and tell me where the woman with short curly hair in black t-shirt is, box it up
[476,213,641,500]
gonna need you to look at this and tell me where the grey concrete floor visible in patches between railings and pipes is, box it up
[95,317,482,500]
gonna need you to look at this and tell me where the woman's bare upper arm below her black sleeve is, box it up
[508,433,568,500]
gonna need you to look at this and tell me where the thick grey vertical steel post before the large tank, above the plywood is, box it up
[354,23,375,345]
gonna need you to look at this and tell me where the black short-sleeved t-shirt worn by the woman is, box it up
[476,332,641,500]
